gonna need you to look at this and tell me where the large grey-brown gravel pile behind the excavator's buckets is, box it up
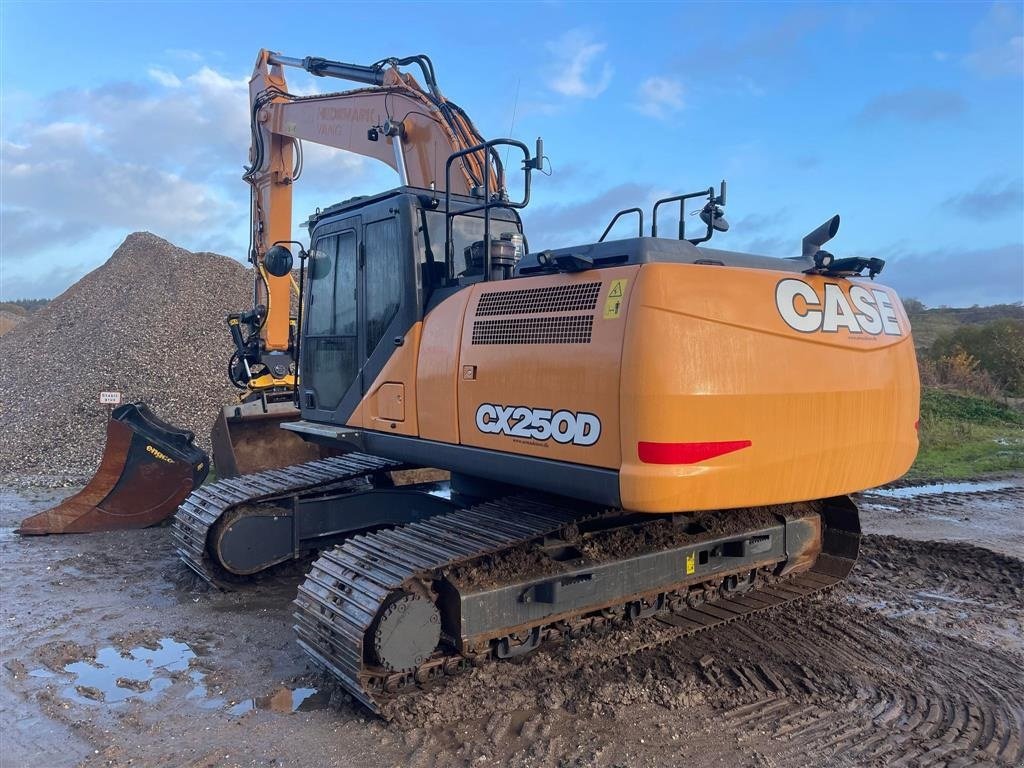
[0,232,252,484]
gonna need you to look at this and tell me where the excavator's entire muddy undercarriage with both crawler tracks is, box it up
[174,454,860,716]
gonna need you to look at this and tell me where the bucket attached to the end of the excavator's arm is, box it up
[210,398,321,478]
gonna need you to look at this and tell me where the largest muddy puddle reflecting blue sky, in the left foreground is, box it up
[63,637,198,703]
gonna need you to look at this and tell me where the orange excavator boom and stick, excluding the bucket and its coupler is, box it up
[244,50,495,360]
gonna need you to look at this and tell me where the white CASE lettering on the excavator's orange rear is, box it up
[775,278,903,336]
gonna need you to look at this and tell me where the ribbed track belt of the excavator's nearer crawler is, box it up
[294,497,859,714]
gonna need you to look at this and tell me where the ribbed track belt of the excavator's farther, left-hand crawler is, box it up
[171,454,401,586]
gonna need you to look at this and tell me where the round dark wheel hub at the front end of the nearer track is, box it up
[373,594,441,672]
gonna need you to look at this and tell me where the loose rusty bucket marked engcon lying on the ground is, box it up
[17,402,210,536]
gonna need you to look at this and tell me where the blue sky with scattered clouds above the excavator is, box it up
[0,0,1024,306]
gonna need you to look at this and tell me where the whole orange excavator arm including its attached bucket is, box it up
[212,50,505,476]
